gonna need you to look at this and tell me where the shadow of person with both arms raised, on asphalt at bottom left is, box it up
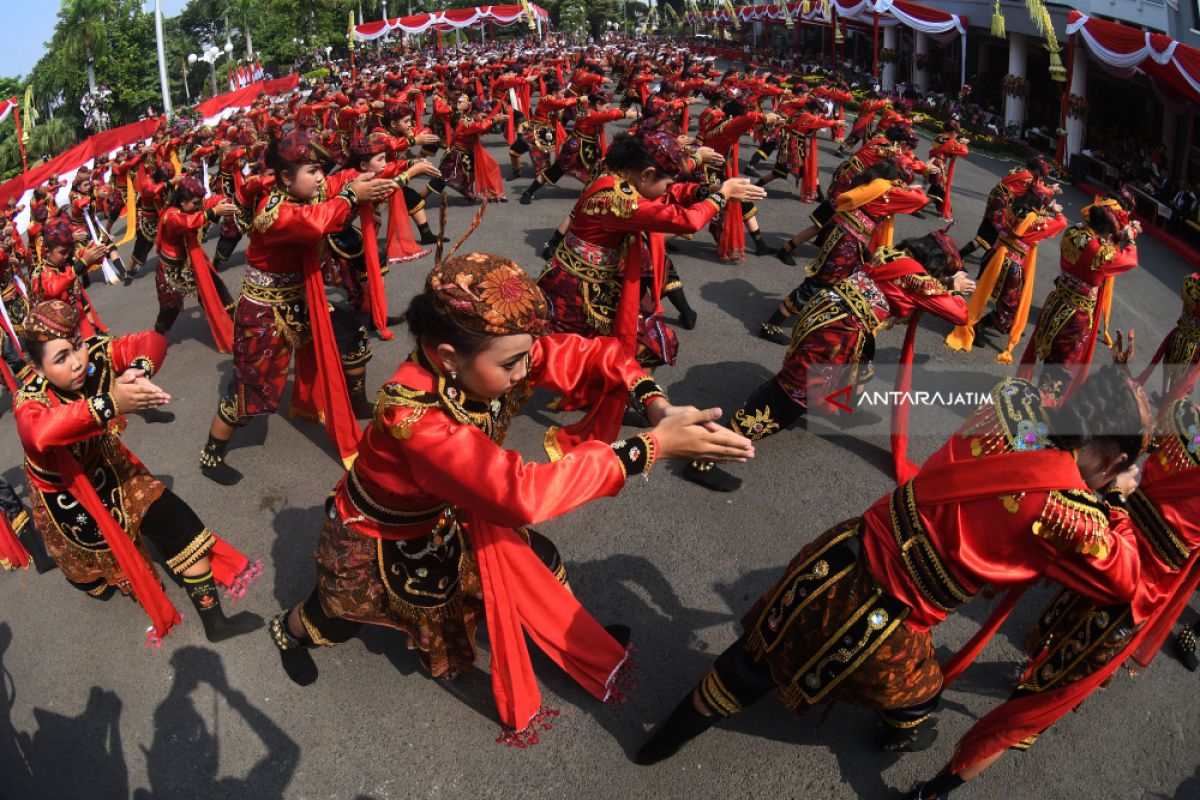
[130,646,300,800]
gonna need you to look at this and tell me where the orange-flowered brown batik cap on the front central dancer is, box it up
[425,253,550,336]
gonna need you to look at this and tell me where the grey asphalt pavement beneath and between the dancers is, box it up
[0,115,1200,800]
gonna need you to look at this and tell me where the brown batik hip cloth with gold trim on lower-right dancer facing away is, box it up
[742,518,942,714]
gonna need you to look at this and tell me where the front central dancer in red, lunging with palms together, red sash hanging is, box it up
[270,253,754,746]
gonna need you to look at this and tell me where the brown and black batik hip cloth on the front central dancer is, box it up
[301,503,566,678]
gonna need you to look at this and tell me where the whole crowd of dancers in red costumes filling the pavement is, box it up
[0,32,1200,798]
